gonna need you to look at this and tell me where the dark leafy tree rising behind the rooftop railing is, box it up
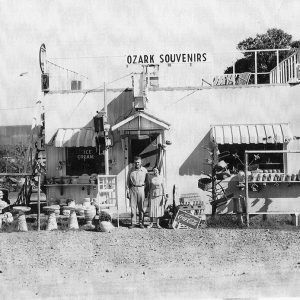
[224,28,300,83]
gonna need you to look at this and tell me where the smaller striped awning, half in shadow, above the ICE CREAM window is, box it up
[50,127,96,147]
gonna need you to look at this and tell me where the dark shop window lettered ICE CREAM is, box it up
[66,147,105,176]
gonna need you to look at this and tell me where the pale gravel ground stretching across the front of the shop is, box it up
[0,216,300,299]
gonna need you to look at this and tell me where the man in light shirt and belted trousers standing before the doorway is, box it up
[127,156,147,228]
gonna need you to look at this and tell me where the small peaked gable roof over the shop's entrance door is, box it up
[111,112,170,131]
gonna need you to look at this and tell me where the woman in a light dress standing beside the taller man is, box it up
[148,167,165,228]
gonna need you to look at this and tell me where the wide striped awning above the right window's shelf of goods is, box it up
[210,123,293,144]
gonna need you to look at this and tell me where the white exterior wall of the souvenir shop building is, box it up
[44,85,300,209]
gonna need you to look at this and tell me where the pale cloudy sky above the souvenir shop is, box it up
[0,0,300,125]
